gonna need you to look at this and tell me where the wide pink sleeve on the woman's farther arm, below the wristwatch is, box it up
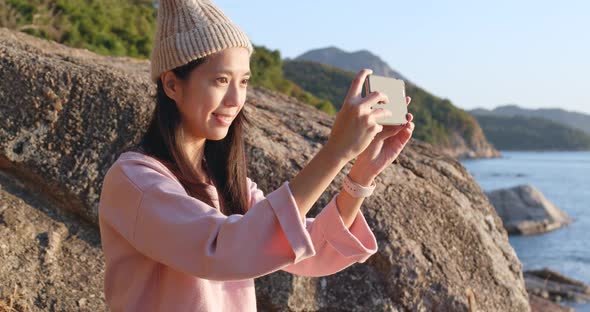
[250,182,378,276]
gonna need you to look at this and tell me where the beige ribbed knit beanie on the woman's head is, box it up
[150,0,254,82]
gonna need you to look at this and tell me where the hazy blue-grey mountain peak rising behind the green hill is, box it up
[294,46,408,81]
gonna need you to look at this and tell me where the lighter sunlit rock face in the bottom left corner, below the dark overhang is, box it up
[0,171,106,311]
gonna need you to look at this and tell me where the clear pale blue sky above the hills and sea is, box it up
[214,0,590,113]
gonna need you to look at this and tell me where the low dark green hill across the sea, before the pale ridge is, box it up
[476,114,590,150]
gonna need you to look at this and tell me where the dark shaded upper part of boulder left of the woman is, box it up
[0,28,155,223]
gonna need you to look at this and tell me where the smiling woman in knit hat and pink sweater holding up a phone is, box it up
[99,0,414,311]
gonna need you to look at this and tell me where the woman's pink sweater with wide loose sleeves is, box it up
[98,152,377,311]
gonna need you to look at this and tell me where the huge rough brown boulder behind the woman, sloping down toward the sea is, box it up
[0,29,530,311]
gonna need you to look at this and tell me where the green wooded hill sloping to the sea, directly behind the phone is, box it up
[283,60,499,157]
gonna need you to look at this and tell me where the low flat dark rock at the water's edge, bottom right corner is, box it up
[524,268,590,302]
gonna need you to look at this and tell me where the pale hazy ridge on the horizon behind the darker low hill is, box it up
[469,105,590,135]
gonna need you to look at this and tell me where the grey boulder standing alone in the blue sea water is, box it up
[486,185,572,235]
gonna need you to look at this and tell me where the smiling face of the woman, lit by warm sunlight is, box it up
[164,48,250,140]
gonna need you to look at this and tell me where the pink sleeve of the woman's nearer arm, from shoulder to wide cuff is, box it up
[99,164,315,280]
